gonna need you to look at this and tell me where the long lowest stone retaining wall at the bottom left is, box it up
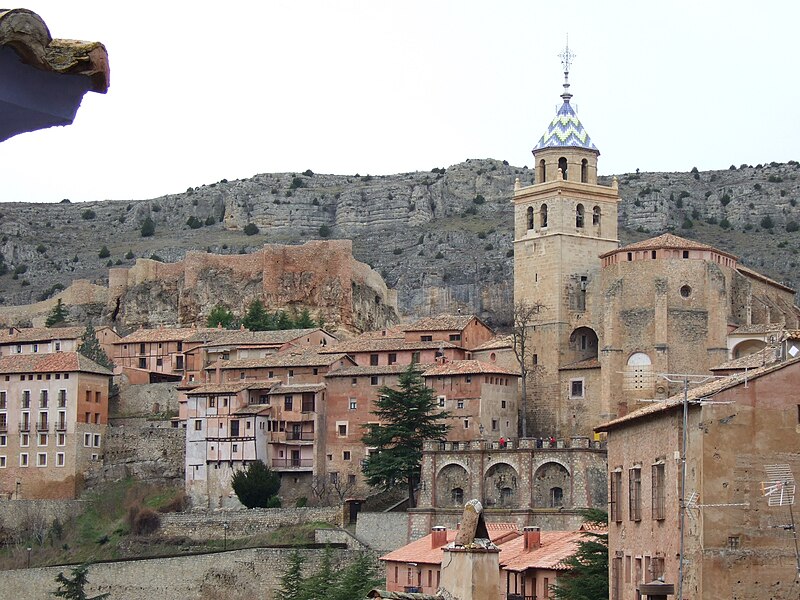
[0,548,372,600]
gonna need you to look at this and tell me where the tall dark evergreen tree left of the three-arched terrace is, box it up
[362,365,450,507]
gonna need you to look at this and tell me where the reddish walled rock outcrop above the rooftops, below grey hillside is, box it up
[106,240,398,331]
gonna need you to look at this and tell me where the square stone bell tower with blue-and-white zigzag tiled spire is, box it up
[513,45,619,437]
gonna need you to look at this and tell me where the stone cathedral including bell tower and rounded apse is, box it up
[513,54,800,438]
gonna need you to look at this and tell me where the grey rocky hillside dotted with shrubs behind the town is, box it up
[0,159,800,328]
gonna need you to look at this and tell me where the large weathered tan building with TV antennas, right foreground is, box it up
[598,358,800,600]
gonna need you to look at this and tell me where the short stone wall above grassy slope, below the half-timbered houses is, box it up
[160,506,342,540]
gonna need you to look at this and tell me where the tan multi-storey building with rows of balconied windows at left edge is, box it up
[0,352,111,499]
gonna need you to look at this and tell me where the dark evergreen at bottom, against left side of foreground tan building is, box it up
[552,509,608,600]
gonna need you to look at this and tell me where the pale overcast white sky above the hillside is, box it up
[0,0,800,202]
